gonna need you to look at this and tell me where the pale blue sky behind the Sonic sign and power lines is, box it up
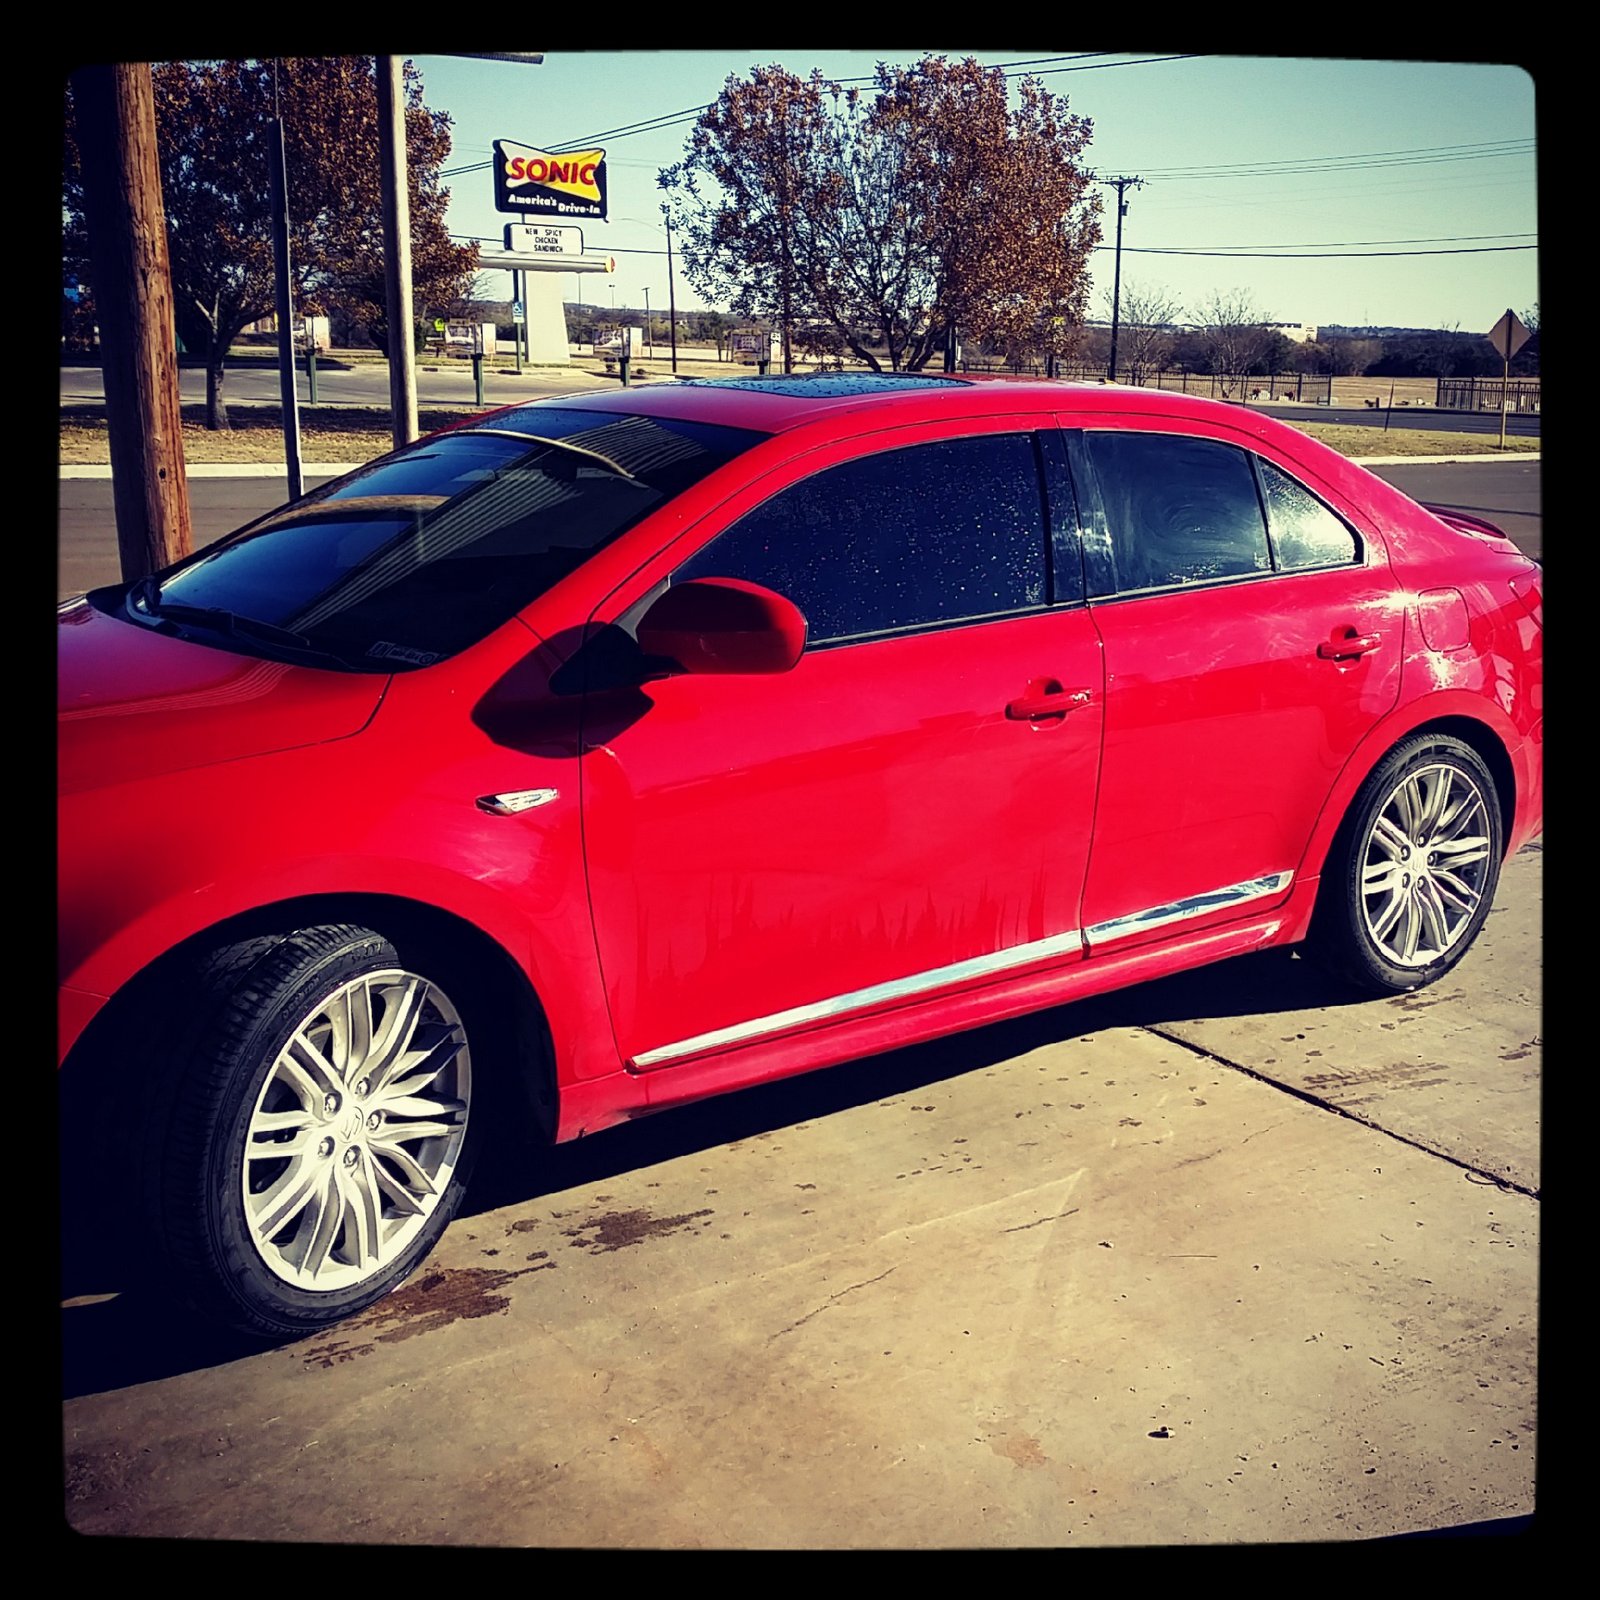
[416,45,1539,331]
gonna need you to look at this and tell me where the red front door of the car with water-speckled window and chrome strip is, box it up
[582,419,1102,1070]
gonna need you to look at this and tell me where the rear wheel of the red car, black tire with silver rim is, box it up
[1310,734,1506,994]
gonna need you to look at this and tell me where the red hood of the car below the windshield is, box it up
[56,600,389,794]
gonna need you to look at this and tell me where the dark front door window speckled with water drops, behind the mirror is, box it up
[672,434,1048,645]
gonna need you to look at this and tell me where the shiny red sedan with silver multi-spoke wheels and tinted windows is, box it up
[59,376,1542,1336]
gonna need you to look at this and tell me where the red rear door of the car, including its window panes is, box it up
[1069,419,1403,952]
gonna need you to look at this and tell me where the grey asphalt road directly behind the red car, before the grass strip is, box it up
[56,459,1542,600]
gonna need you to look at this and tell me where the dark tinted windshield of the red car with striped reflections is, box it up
[111,405,765,672]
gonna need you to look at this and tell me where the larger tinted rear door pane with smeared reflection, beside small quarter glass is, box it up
[1083,430,1272,590]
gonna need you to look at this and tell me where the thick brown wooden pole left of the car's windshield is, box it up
[72,64,190,582]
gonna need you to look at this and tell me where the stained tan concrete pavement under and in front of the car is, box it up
[62,843,1542,1549]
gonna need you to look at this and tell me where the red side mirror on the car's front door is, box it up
[638,578,806,674]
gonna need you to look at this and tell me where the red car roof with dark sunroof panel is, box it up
[499,373,1260,434]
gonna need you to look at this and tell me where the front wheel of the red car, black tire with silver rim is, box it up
[147,925,483,1338]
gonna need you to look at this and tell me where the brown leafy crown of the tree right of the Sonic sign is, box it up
[661,56,1099,371]
